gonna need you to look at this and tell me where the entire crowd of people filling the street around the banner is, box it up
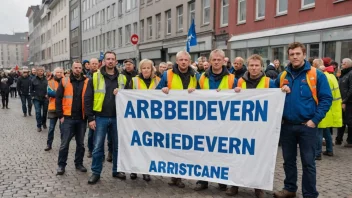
[0,42,352,198]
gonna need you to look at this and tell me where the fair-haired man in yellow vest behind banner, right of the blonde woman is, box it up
[156,51,198,188]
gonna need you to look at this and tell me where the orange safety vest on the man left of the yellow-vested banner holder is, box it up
[61,77,88,118]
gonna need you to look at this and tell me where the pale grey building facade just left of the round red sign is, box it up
[81,0,139,63]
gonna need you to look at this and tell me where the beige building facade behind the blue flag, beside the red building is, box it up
[139,0,215,64]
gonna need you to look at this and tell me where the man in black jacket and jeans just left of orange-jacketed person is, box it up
[31,67,49,132]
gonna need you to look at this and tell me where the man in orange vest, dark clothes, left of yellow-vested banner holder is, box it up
[55,61,88,175]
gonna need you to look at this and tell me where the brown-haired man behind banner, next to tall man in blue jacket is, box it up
[230,54,290,198]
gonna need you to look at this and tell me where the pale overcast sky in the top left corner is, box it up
[0,0,41,34]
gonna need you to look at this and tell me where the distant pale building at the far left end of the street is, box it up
[0,32,28,69]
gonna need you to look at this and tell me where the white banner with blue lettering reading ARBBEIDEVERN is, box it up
[116,89,285,190]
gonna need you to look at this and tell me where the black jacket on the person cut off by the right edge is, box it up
[339,68,352,104]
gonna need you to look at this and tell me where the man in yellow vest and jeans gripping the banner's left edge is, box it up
[84,51,126,184]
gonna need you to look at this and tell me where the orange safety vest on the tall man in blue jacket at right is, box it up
[280,67,319,104]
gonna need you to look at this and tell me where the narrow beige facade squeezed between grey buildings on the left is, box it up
[70,0,82,60]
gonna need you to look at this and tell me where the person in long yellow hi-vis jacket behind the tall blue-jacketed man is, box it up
[313,59,342,160]
